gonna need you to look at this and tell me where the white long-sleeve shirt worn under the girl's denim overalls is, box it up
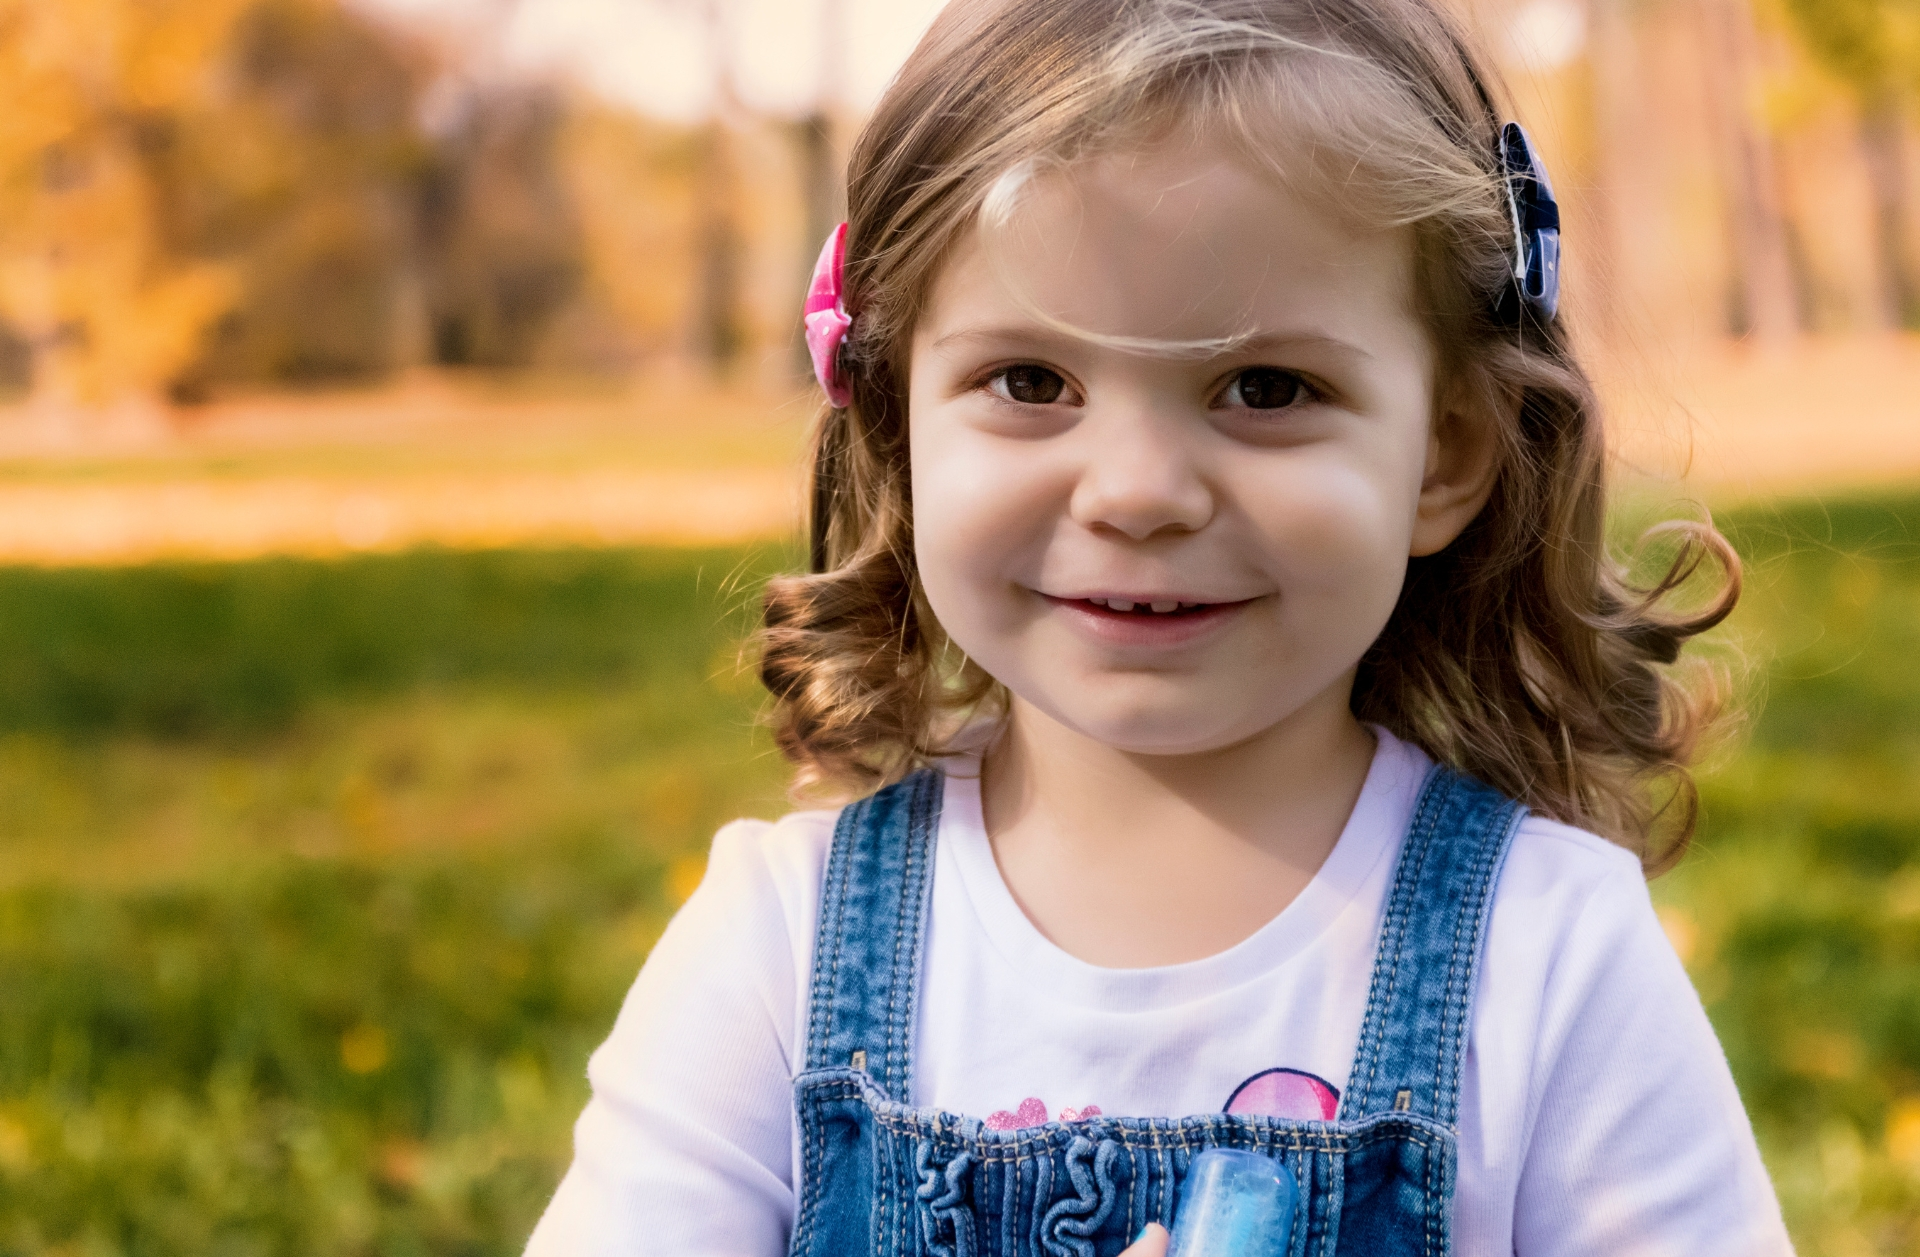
[528,731,1791,1257]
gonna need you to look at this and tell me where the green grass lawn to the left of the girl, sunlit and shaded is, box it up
[0,553,783,1257]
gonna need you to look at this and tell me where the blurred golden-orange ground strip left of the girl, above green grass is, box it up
[0,376,808,564]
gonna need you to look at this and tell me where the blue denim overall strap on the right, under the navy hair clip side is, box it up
[1340,766,1524,1127]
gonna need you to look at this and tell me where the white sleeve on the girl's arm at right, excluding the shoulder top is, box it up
[1513,864,1793,1257]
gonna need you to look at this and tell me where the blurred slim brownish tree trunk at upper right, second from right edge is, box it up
[1699,0,1801,344]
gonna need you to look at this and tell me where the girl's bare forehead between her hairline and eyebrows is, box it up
[916,142,1425,357]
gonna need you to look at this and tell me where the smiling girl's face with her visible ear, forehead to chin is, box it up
[910,139,1492,754]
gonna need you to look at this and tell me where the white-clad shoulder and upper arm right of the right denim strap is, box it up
[1463,832,1789,1253]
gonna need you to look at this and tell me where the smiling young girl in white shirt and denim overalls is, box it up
[530,0,1788,1257]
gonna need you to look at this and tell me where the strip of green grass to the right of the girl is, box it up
[1655,497,1920,1255]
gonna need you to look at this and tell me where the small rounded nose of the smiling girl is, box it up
[1068,409,1215,541]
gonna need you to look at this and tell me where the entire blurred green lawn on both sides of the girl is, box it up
[0,497,1920,1257]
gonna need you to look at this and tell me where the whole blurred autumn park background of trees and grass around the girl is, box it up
[0,0,1920,1257]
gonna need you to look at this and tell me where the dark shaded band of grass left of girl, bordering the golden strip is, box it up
[0,551,771,739]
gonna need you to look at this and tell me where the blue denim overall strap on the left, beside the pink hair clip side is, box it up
[806,770,943,1103]
